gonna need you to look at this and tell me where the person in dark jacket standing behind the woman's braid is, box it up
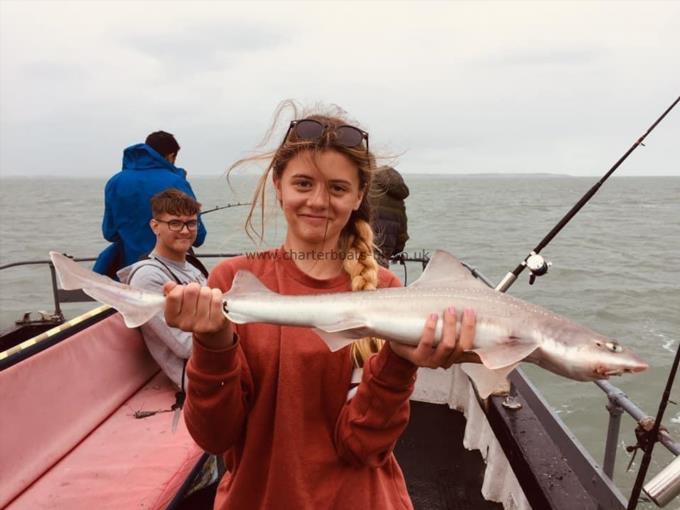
[371,166,409,267]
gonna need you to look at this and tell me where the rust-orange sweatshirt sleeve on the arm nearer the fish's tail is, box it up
[184,267,253,454]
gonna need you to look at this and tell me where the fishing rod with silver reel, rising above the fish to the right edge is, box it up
[496,97,680,292]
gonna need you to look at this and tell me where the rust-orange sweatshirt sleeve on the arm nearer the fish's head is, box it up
[335,268,418,467]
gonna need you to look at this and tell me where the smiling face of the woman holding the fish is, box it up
[274,150,364,249]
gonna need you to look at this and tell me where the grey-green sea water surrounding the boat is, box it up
[0,175,680,508]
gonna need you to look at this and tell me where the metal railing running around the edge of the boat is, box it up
[0,252,680,500]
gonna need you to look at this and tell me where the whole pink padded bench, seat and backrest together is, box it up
[0,314,202,510]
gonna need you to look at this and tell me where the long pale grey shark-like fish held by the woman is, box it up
[50,250,648,398]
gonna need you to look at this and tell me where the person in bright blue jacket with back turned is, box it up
[93,131,206,278]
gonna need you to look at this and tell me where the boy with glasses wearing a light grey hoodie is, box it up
[118,188,207,388]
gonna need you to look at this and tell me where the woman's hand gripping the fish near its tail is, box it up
[163,282,233,349]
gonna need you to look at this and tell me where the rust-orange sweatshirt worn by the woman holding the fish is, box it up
[184,249,417,510]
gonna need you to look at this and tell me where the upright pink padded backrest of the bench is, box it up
[0,314,158,508]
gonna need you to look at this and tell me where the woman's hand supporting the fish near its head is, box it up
[390,307,476,368]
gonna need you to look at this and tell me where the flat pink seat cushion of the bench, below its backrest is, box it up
[7,372,203,510]
